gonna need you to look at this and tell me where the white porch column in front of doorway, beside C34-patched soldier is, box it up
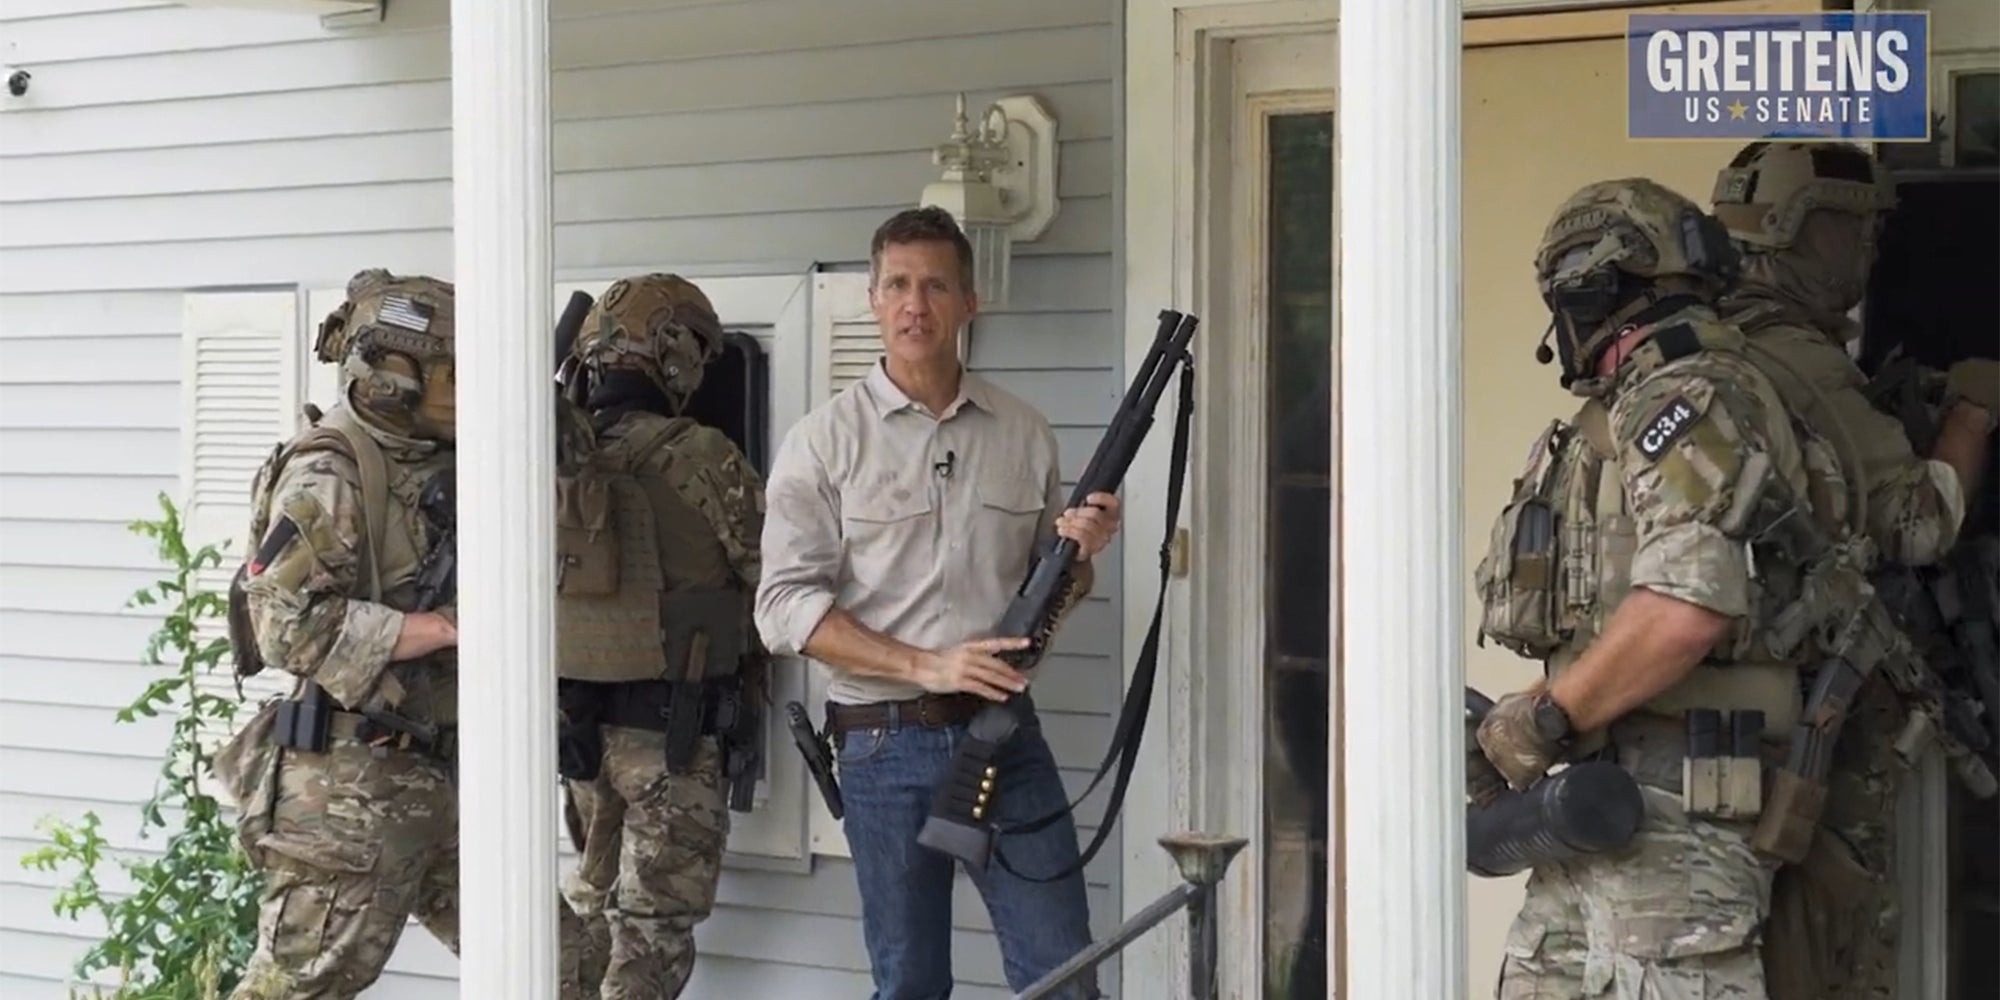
[1330,0,1466,1000]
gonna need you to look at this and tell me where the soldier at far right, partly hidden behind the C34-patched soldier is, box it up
[1714,142,2000,998]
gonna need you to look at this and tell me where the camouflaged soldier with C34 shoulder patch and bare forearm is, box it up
[1476,178,1820,1000]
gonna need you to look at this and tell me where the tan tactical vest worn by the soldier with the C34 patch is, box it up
[1474,320,1844,750]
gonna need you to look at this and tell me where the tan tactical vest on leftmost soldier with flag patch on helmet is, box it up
[228,406,458,724]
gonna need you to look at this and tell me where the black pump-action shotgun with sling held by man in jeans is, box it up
[916,310,1200,882]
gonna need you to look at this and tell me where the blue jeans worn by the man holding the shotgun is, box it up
[840,718,1102,1000]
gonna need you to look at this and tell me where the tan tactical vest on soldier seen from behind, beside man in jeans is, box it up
[556,414,750,684]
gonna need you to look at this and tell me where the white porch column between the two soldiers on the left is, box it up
[452,0,558,1000]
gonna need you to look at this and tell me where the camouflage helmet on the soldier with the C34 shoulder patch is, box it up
[1534,178,1742,386]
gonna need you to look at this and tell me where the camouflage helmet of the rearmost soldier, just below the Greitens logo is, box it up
[1712,142,1896,250]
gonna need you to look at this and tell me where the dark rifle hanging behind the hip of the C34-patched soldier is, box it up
[1744,454,1996,864]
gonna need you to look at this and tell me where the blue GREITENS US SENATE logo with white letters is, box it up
[1626,12,1930,142]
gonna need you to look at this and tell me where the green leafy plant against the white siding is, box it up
[22,494,262,1000]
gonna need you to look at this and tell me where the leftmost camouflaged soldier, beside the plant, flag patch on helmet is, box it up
[216,270,458,1000]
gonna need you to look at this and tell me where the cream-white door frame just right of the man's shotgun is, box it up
[1120,0,1336,996]
